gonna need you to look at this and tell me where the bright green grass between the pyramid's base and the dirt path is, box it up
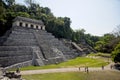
[20,57,108,70]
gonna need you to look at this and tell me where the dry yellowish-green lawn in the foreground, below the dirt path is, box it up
[22,71,120,80]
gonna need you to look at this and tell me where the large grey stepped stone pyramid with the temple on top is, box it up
[0,16,95,68]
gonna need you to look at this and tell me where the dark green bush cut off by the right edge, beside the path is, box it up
[112,43,120,62]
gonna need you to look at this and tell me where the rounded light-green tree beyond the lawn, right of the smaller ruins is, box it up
[95,34,116,53]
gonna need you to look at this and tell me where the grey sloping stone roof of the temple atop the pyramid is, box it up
[13,16,44,25]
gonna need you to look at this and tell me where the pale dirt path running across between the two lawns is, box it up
[21,67,114,75]
